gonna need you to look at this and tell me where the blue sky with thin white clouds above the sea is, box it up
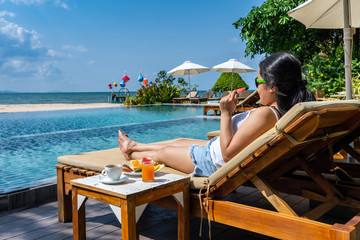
[0,0,264,92]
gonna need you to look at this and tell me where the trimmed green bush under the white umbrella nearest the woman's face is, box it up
[211,73,249,91]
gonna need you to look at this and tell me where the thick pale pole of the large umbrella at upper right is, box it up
[343,0,353,100]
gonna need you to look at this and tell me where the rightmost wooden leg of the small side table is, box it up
[177,183,190,240]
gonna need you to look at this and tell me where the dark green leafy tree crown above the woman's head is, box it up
[233,0,342,63]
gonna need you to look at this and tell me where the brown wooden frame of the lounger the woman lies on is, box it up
[57,102,360,240]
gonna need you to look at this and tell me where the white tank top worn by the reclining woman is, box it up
[210,107,279,168]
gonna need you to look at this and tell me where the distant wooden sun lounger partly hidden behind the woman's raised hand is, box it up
[203,91,260,116]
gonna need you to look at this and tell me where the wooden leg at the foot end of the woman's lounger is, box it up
[56,168,72,222]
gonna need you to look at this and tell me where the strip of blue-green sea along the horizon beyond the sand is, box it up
[0,91,205,105]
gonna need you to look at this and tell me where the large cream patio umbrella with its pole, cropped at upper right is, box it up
[288,0,360,99]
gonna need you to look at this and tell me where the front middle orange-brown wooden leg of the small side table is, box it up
[120,198,139,240]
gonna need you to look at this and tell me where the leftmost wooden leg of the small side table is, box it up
[71,188,86,240]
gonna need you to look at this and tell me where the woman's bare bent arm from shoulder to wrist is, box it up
[220,100,276,162]
